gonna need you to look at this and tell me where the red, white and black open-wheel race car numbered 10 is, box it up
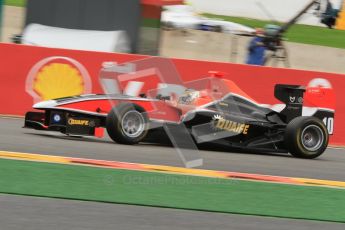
[24,71,335,159]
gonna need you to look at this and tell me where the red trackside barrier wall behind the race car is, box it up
[0,44,345,145]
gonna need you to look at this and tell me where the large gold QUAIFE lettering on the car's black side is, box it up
[214,115,250,135]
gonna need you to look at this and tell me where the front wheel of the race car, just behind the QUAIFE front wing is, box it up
[106,103,148,145]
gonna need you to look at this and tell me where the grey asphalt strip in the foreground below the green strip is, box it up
[0,195,344,230]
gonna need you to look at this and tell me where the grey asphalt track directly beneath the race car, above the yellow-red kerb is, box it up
[0,118,345,181]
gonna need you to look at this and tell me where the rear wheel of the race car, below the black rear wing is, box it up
[285,117,329,159]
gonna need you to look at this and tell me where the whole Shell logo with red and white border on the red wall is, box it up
[26,57,92,103]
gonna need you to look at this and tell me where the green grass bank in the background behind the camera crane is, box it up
[204,14,345,49]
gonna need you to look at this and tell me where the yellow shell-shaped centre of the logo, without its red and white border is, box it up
[33,63,84,100]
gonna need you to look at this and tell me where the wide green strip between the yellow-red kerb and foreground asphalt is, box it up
[0,159,345,222]
